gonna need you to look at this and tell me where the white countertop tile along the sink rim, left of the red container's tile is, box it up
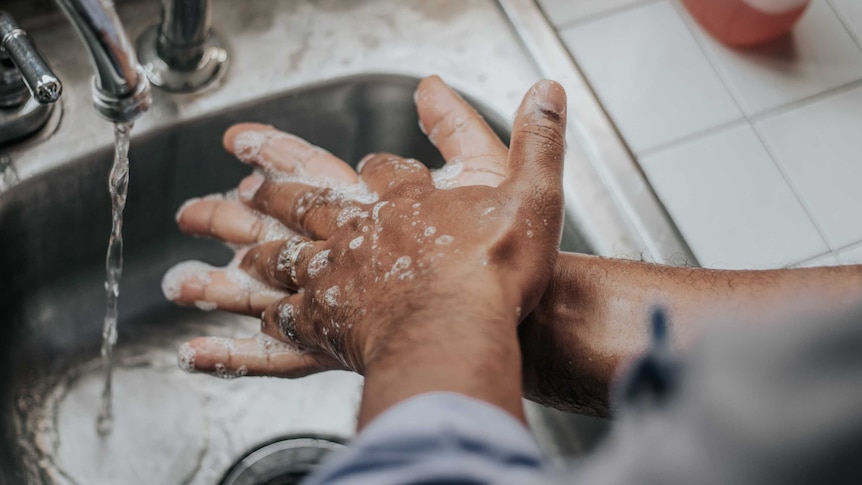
[561,2,742,153]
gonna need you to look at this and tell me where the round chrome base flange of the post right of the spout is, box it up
[138,25,228,93]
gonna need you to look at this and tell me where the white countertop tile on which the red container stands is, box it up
[677,0,862,116]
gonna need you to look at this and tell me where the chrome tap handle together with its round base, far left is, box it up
[0,11,63,144]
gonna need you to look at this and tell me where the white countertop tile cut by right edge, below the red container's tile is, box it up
[756,87,862,248]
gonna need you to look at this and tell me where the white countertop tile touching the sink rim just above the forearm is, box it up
[641,125,828,268]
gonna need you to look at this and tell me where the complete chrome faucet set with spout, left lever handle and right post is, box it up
[0,0,228,144]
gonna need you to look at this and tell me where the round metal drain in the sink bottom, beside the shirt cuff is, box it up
[221,436,344,485]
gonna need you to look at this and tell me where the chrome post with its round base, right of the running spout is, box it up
[138,0,228,92]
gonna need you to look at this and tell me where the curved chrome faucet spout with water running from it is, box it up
[57,0,150,123]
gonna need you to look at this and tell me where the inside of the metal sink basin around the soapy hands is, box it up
[0,75,592,484]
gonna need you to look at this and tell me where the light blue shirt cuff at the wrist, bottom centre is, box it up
[307,392,550,484]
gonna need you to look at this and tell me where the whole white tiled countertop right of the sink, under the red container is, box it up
[537,0,862,268]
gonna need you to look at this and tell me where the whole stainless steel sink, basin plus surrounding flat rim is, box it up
[0,0,696,484]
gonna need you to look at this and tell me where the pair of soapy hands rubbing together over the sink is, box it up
[166,78,565,376]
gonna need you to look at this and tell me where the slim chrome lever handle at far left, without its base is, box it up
[0,11,63,104]
